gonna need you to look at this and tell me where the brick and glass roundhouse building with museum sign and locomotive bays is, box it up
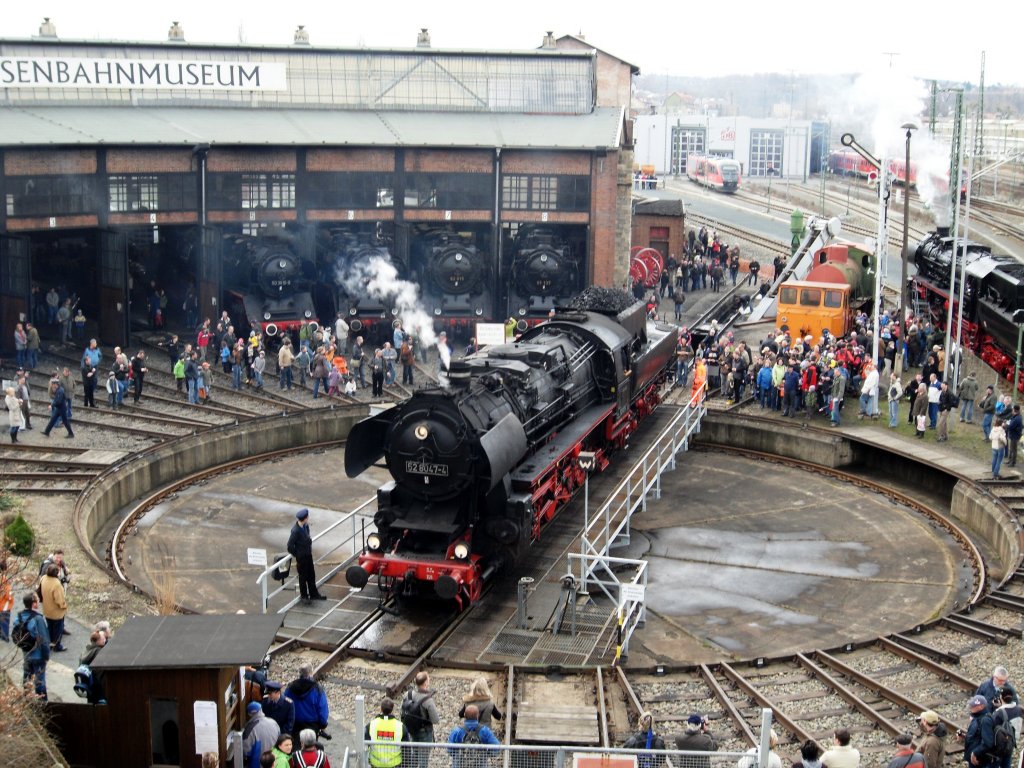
[0,20,637,350]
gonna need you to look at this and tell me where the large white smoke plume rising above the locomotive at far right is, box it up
[829,68,951,225]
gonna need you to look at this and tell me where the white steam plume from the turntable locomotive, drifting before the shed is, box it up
[335,256,437,349]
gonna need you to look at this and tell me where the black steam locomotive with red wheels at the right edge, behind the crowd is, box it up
[911,229,1024,391]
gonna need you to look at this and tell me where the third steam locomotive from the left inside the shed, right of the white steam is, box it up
[413,229,495,338]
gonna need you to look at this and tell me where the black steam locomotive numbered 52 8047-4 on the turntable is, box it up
[345,295,676,607]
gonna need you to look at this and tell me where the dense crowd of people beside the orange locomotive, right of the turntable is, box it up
[676,296,1024,479]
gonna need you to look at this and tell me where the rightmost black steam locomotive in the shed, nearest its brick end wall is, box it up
[509,225,583,318]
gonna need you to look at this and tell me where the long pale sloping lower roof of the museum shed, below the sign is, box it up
[0,106,624,150]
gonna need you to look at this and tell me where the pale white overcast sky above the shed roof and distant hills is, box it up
[0,0,1024,85]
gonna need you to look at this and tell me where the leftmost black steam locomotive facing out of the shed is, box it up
[225,238,316,336]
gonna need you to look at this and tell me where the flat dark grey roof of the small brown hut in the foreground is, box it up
[90,613,284,670]
